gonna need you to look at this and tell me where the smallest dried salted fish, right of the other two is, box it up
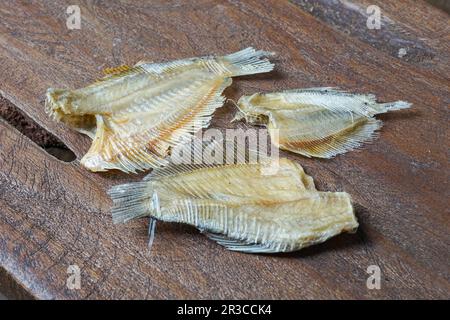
[235,88,410,158]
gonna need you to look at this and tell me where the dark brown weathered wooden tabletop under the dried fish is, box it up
[0,0,450,299]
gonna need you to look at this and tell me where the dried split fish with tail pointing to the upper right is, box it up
[46,48,273,172]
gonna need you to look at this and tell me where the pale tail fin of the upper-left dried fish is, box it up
[224,47,274,76]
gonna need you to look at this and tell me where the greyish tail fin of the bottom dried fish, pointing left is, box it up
[108,181,155,223]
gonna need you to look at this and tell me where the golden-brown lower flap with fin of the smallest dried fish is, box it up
[279,117,382,158]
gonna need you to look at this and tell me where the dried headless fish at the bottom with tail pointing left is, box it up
[109,145,358,253]
